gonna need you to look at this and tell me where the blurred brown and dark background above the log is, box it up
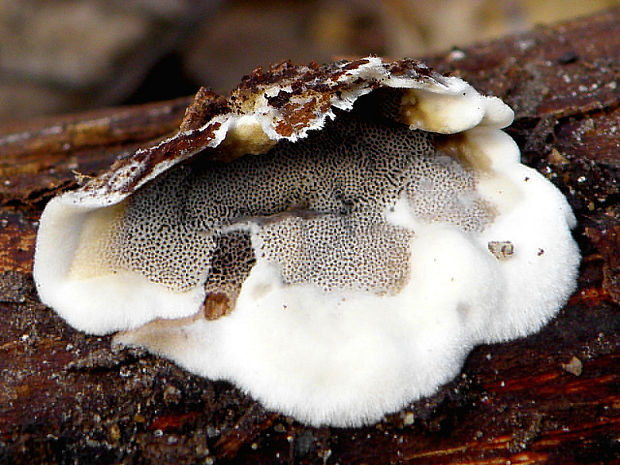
[0,0,620,122]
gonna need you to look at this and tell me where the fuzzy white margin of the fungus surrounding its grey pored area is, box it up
[34,58,579,426]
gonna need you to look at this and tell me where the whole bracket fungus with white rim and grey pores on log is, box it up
[34,57,579,426]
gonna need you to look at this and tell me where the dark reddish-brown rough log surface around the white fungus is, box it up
[0,9,620,465]
